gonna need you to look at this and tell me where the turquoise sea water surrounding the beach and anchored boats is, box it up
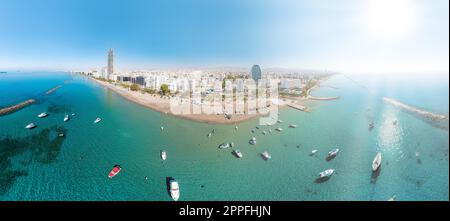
[0,72,449,201]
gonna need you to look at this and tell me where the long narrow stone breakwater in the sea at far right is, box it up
[383,97,449,131]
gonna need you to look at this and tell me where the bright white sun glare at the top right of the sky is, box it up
[364,0,414,37]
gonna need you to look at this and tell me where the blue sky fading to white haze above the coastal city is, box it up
[0,0,449,73]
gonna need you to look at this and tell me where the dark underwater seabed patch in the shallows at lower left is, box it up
[0,126,67,195]
